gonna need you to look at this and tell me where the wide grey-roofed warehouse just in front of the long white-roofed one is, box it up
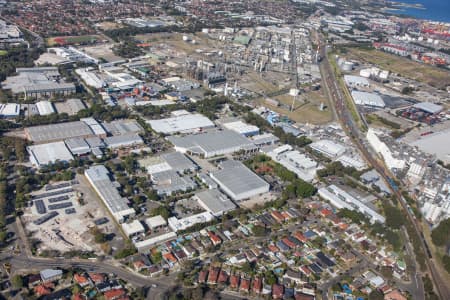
[167,130,257,158]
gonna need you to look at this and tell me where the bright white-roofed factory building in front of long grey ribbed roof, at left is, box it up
[27,142,73,168]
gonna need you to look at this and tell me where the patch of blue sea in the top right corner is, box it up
[386,0,450,23]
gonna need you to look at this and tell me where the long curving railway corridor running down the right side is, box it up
[320,35,450,300]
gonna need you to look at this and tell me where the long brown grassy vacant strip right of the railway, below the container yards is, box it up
[346,48,450,88]
